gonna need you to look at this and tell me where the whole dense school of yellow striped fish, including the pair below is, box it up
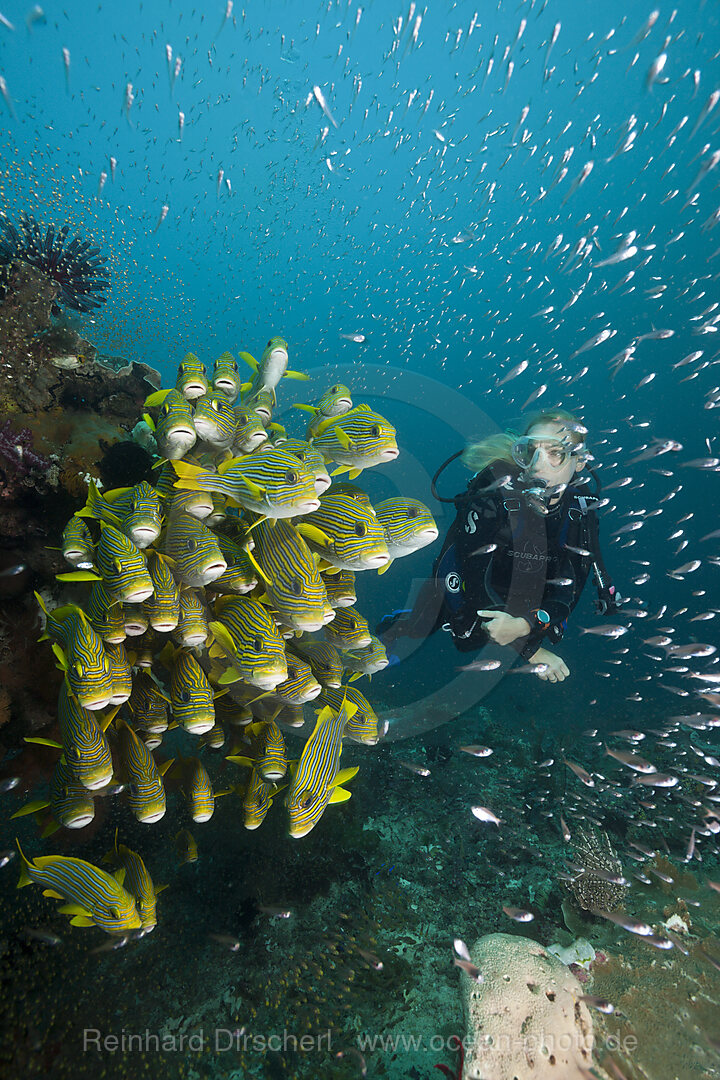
[9,337,437,936]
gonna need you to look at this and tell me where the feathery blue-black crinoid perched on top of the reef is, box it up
[0,214,110,311]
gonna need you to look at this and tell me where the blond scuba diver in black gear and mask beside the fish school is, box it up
[376,409,622,683]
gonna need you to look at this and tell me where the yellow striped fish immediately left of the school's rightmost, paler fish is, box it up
[296,488,390,570]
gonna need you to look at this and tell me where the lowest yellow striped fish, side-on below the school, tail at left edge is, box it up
[17,842,141,934]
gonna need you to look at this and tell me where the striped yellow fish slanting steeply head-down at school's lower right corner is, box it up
[287,701,357,838]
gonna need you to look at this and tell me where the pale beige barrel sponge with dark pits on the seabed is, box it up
[462,934,593,1080]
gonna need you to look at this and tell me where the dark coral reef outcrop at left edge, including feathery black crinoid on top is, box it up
[0,217,160,746]
